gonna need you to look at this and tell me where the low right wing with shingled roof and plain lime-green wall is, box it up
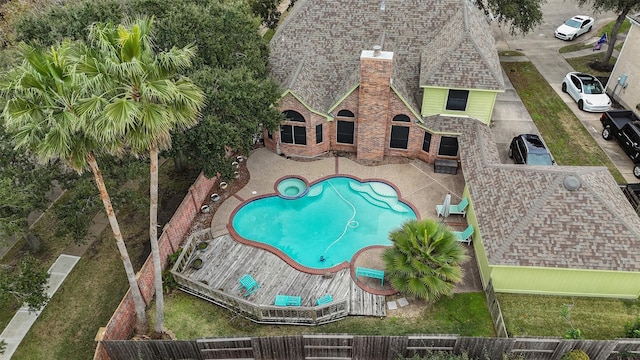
[460,122,640,299]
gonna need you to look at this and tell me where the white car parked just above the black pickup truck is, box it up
[562,71,611,112]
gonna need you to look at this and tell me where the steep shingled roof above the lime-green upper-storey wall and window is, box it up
[420,6,504,90]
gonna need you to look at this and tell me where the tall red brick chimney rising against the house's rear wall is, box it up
[356,46,393,161]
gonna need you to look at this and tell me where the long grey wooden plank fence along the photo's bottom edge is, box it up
[102,334,640,360]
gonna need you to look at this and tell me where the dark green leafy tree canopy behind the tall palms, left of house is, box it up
[11,0,281,178]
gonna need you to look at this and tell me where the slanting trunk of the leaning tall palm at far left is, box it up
[87,153,149,334]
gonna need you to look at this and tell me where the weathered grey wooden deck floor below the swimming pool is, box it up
[176,234,386,316]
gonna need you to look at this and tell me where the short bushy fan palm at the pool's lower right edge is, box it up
[383,219,468,301]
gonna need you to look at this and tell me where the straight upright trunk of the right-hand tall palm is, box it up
[149,144,164,337]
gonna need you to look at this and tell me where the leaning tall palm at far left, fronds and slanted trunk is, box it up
[0,42,149,333]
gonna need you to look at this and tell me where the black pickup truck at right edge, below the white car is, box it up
[600,110,640,179]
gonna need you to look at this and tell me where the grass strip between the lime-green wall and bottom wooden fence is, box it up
[498,294,640,339]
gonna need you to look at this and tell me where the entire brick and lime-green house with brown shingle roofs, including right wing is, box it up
[265,0,640,298]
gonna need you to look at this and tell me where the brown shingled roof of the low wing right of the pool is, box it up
[460,122,640,271]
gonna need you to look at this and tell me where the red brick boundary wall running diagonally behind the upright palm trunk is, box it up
[94,174,217,360]
